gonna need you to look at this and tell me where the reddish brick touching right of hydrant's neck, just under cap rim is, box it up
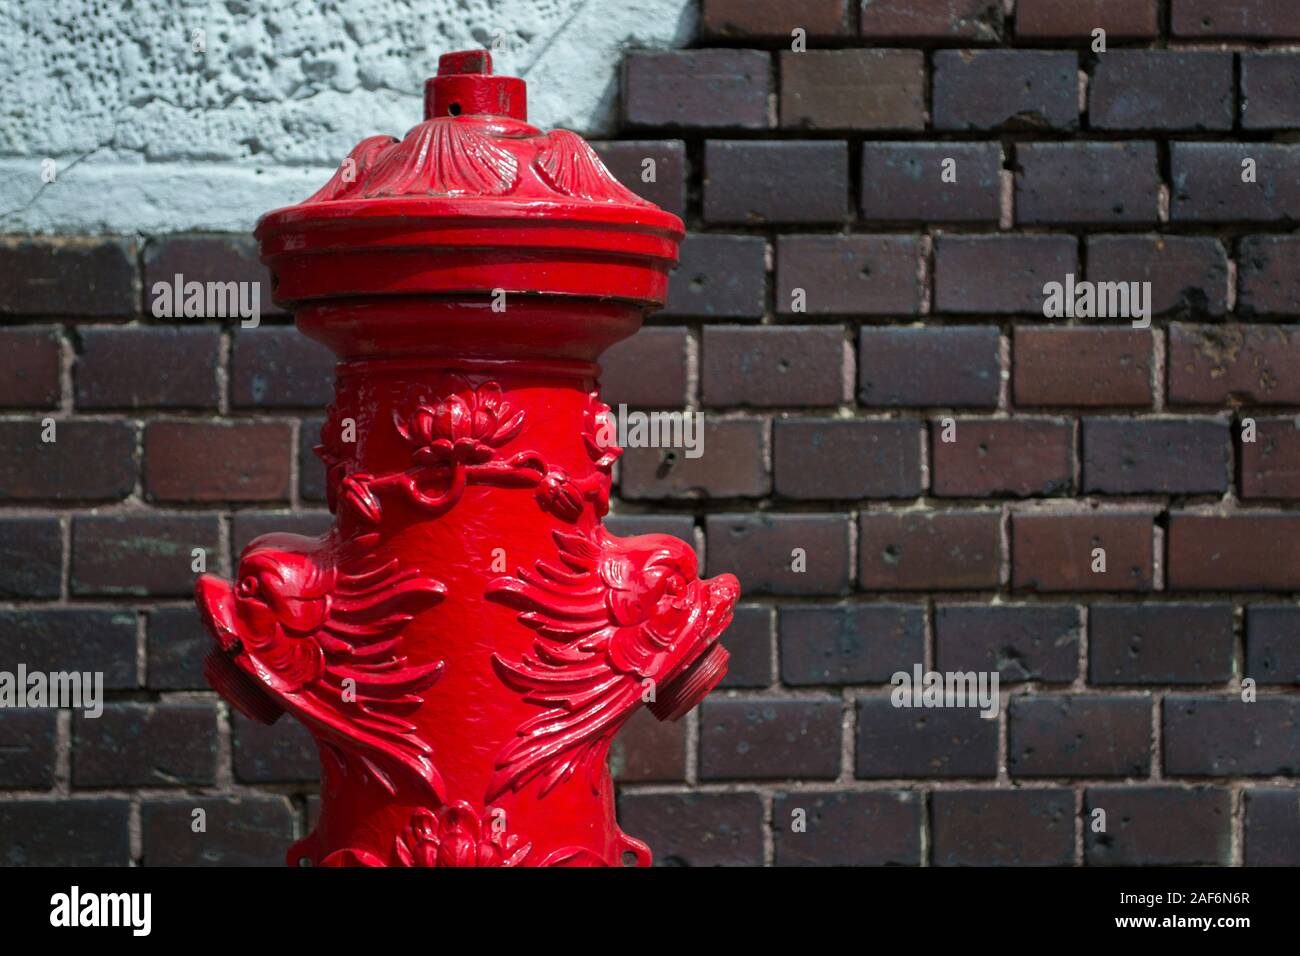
[601,325,688,408]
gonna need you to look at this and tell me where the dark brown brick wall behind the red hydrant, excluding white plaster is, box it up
[0,0,1300,865]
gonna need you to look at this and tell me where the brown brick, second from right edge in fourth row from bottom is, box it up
[1011,511,1153,591]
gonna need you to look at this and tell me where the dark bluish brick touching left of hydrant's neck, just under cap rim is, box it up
[230,326,335,408]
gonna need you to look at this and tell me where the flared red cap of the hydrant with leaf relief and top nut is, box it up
[256,51,683,308]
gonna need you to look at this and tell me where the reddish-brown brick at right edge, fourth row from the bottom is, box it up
[1169,511,1300,591]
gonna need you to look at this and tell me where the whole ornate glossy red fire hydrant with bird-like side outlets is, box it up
[198,52,738,866]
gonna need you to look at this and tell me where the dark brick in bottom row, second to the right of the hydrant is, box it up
[772,790,922,866]
